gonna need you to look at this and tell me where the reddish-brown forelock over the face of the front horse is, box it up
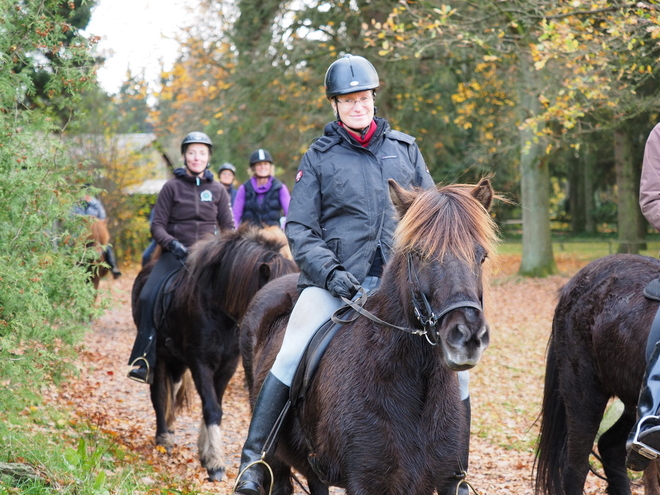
[394,184,497,263]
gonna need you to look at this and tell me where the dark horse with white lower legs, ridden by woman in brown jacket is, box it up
[132,226,297,480]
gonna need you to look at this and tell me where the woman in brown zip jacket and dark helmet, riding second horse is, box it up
[128,132,234,383]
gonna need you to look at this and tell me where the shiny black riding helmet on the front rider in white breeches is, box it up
[324,53,380,98]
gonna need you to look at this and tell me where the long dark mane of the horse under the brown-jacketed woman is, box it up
[182,225,295,318]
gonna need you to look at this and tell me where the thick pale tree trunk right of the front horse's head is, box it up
[519,57,557,277]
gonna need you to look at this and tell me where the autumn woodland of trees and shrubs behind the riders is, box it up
[0,0,660,493]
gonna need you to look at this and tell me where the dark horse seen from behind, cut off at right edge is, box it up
[535,254,660,495]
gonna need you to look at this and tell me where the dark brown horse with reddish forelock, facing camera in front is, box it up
[241,179,496,495]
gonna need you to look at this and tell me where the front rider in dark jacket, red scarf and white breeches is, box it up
[234,55,470,495]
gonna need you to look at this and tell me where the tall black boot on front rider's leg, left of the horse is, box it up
[233,373,289,495]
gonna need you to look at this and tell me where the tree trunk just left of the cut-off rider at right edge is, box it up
[614,129,640,254]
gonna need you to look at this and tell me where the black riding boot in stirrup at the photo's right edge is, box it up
[626,344,660,471]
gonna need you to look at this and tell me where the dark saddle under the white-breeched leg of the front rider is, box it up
[291,306,356,404]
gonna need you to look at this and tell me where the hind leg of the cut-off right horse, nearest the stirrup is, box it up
[598,409,635,495]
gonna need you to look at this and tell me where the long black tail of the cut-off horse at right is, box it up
[534,336,567,495]
